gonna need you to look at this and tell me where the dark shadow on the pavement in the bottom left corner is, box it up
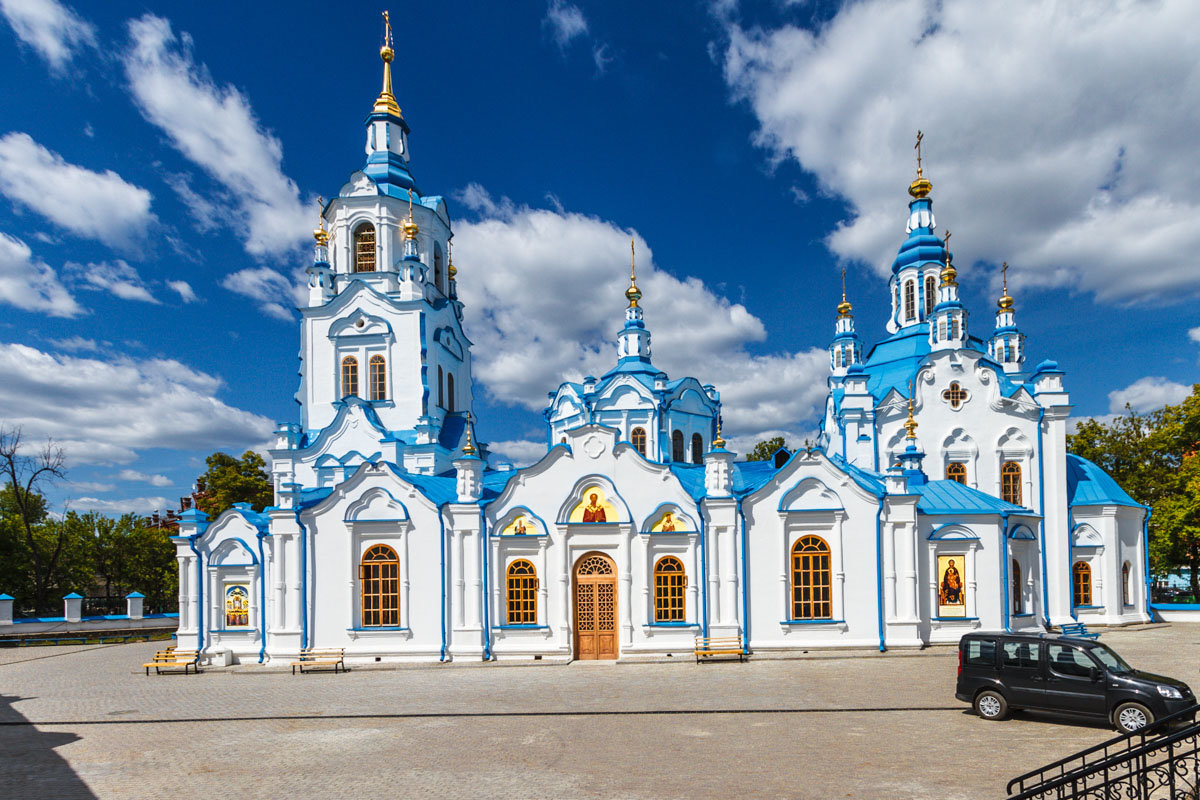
[0,694,96,800]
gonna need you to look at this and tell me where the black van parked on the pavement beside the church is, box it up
[954,633,1196,732]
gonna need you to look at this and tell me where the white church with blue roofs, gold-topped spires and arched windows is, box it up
[173,25,1150,664]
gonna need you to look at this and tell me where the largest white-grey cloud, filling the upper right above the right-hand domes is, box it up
[725,0,1200,302]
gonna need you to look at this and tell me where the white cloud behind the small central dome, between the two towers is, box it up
[455,187,828,448]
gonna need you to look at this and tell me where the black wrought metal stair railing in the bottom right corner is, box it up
[1007,705,1200,800]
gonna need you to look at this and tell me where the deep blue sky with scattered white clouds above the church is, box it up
[0,0,1200,512]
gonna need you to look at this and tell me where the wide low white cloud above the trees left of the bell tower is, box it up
[0,344,272,465]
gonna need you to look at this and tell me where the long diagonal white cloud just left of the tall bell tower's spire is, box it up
[124,14,313,257]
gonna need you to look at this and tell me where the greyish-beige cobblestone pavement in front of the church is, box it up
[0,625,1200,800]
